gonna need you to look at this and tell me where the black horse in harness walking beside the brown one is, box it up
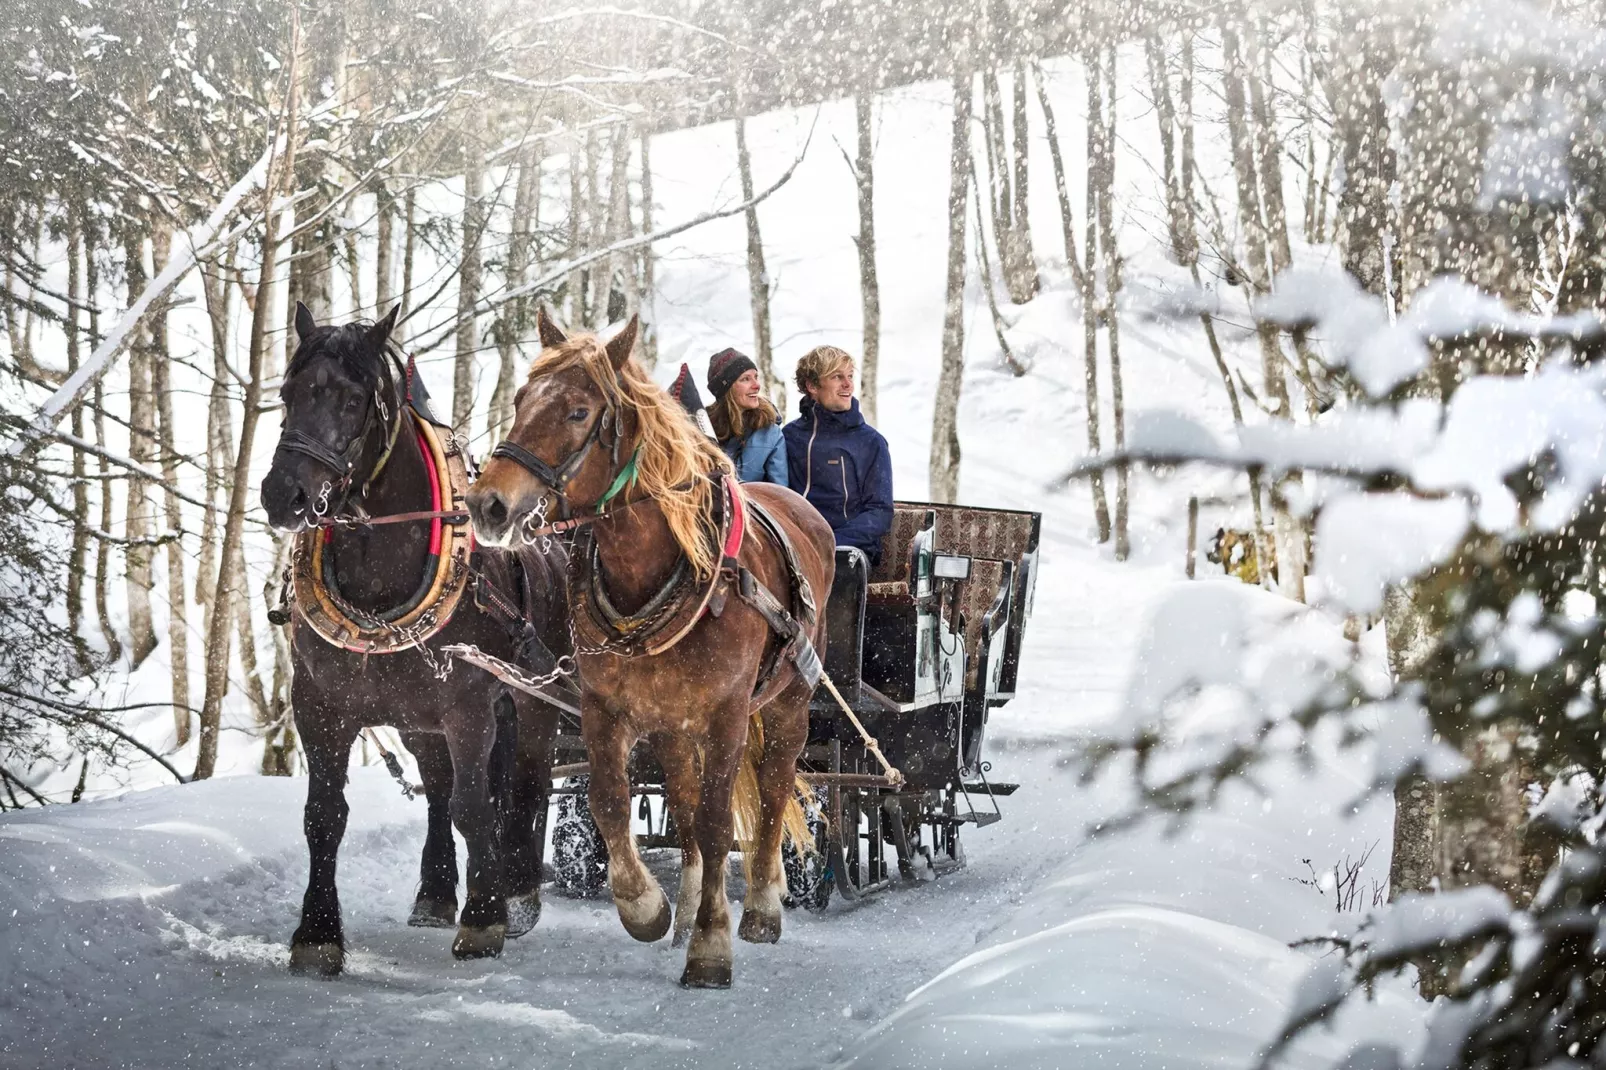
[262,305,570,974]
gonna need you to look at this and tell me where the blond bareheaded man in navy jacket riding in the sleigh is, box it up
[782,345,893,567]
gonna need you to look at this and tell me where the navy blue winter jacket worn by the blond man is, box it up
[784,398,893,566]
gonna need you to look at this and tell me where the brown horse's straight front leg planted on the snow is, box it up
[681,697,747,988]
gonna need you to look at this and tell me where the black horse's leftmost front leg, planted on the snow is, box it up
[291,704,357,977]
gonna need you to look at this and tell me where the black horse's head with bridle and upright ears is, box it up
[262,302,403,530]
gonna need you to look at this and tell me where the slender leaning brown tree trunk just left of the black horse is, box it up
[194,20,300,779]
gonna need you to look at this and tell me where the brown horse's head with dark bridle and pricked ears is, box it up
[467,308,644,546]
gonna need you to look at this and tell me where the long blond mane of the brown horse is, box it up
[530,334,734,578]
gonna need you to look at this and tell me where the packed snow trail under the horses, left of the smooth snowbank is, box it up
[0,752,1076,1067]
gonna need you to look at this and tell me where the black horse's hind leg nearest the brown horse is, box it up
[503,692,557,938]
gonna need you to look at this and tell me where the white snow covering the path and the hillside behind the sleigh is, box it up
[0,67,1421,1068]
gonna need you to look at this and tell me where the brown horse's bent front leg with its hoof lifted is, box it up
[580,702,670,941]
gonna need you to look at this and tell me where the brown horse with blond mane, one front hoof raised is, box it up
[467,310,835,988]
